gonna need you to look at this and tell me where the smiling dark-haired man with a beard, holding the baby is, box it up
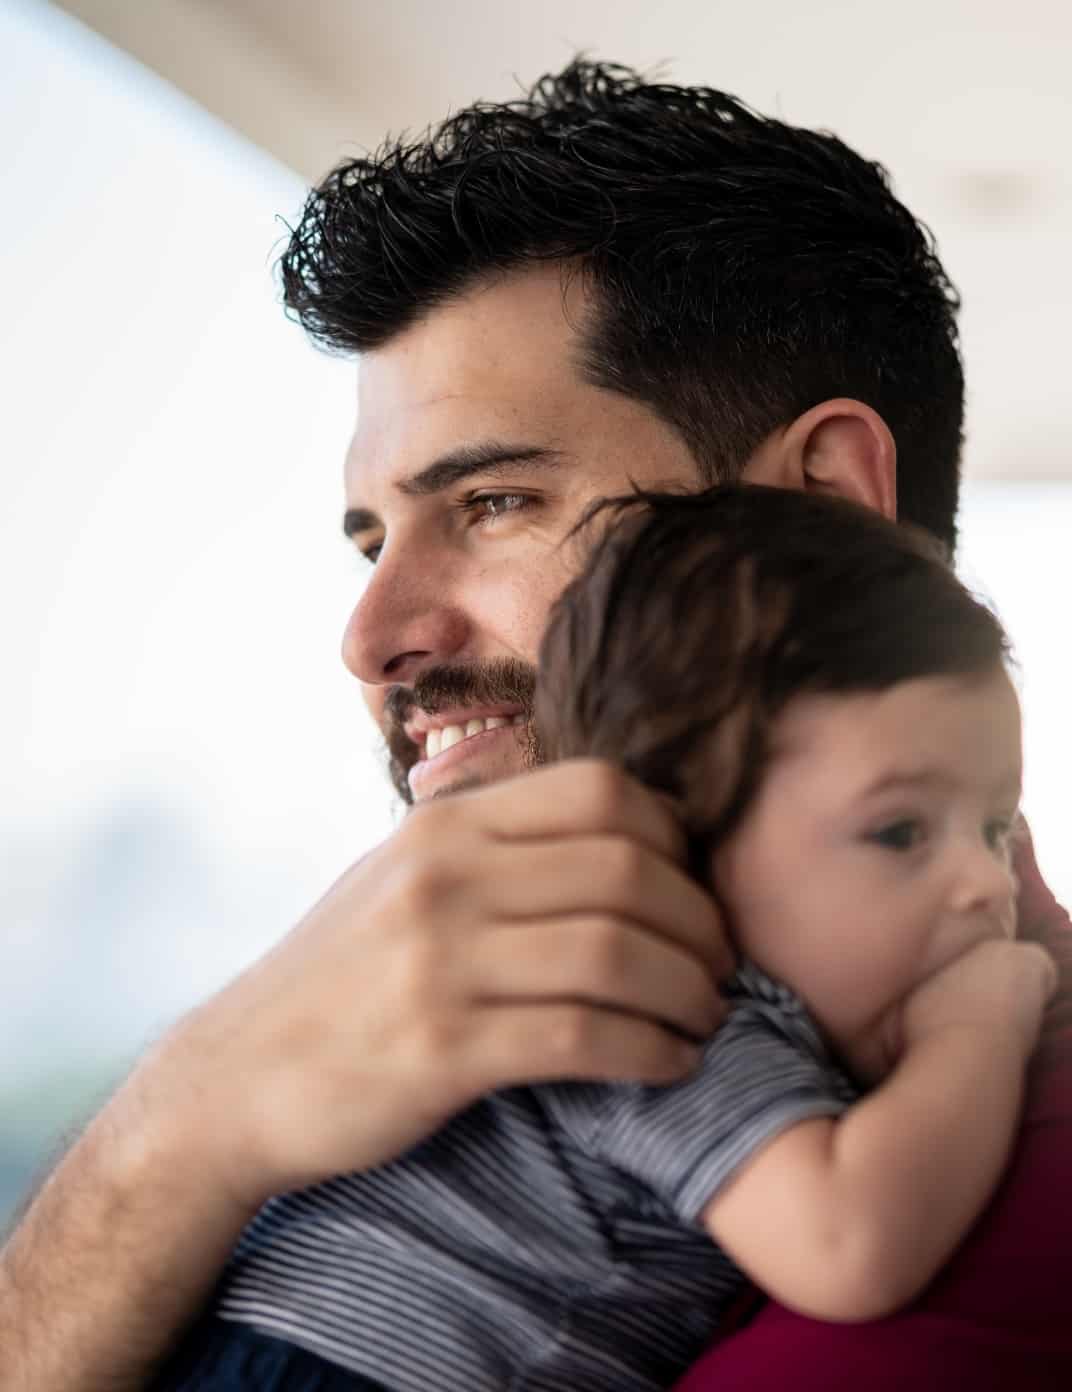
[0,64,1058,1392]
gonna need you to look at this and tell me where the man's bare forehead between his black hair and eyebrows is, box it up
[338,267,696,512]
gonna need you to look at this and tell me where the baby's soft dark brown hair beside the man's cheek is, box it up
[536,484,1009,852]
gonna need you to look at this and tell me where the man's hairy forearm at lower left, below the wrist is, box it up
[0,1052,251,1392]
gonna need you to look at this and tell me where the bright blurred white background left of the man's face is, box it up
[0,0,390,1211]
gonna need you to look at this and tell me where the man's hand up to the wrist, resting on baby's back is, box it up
[169,760,732,1201]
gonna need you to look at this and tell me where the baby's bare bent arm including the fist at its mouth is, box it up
[703,942,1055,1320]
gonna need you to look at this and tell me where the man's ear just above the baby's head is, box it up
[741,397,897,521]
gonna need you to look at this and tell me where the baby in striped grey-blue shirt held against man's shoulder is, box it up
[159,487,1054,1392]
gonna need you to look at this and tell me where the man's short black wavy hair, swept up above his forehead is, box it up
[281,60,963,547]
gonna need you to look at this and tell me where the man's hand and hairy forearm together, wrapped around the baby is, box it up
[0,761,731,1392]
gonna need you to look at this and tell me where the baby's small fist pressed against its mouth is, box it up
[901,941,1057,1059]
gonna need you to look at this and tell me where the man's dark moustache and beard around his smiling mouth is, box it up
[383,657,543,803]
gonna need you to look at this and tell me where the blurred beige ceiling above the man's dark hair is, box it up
[56,0,1072,479]
